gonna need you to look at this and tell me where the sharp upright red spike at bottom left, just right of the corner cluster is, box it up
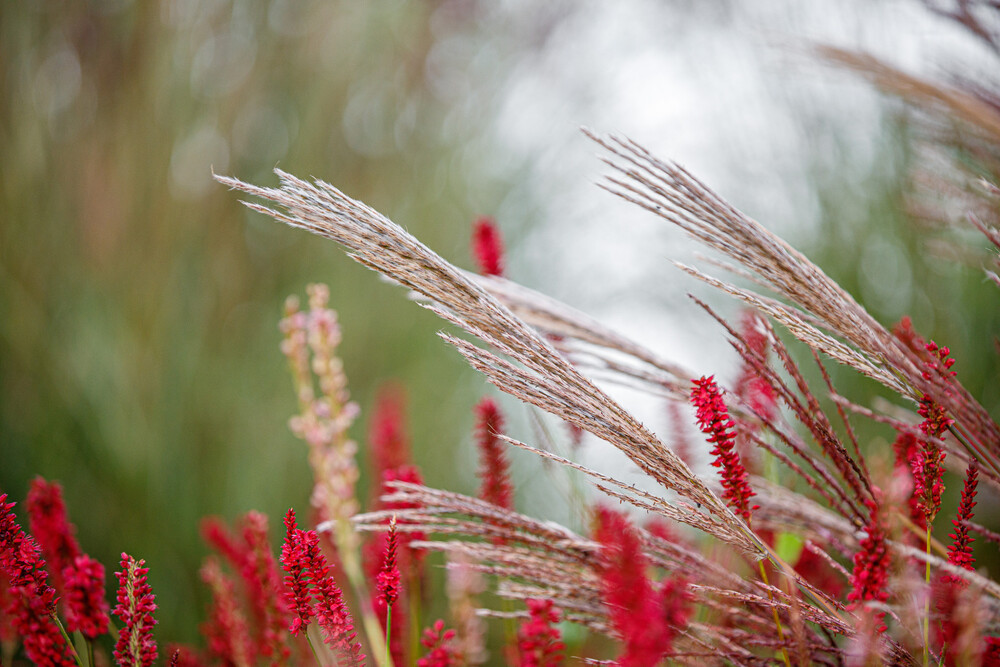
[114,553,156,667]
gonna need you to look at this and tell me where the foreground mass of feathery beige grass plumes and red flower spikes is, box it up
[0,3,1000,667]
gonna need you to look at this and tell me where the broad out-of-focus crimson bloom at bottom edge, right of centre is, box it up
[594,507,691,667]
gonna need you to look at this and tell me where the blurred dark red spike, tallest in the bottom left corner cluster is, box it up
[25,477,81,595]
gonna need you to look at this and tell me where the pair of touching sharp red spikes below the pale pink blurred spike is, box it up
[281,509,364,665]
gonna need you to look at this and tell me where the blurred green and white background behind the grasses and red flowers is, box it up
[0,0,1000,652]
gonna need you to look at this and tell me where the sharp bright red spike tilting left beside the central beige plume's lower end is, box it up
[691,376,758,521]
